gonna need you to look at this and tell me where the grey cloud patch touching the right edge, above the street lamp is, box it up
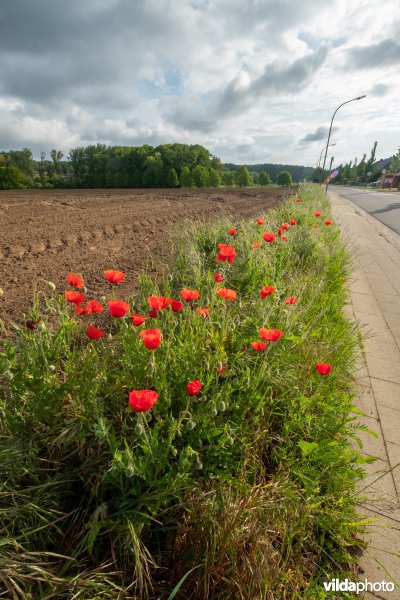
[346,40,400,69]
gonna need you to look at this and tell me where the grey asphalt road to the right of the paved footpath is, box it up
[329,185,400,235]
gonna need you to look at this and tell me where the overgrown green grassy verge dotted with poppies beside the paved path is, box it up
[0,186,361,600]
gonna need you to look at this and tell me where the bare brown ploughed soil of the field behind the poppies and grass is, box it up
[0,188,288,323]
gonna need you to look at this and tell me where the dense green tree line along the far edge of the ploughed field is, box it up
[0,143,304,189]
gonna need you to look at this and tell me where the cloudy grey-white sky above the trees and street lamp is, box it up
[0,0,400,166]
